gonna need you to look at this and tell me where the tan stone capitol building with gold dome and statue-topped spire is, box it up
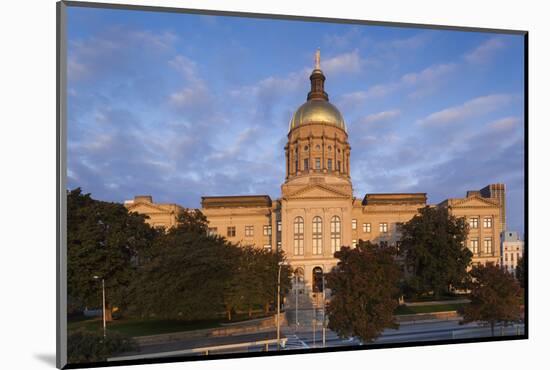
[125,53,506,290]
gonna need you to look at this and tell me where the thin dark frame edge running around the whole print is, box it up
[56,1,529,369]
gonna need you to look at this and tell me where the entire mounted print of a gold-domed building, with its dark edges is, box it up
[57,1,528,368]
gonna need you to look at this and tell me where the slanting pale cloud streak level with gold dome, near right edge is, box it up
[417,94,512,126]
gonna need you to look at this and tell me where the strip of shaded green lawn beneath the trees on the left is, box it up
[67,314,274,337]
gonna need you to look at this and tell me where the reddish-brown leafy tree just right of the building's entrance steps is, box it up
[326,241,401,342]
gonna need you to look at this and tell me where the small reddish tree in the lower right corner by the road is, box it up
[461,264,522,335]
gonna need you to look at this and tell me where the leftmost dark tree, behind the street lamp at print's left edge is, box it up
[67,188,156,320]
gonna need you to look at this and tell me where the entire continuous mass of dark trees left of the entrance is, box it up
[67,188,290,320]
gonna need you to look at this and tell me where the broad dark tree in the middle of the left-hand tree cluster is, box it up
[133,210,239,320]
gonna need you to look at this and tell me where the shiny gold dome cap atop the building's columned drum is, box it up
[288,99,347,132]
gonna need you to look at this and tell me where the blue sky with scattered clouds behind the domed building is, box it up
[67,7,525,233]
